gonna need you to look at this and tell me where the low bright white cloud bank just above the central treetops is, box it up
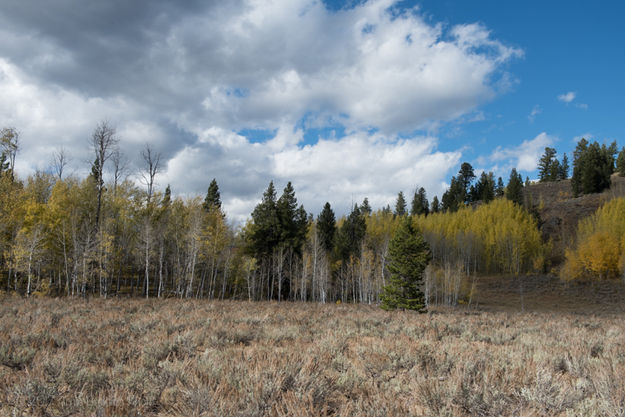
[163,129,461,222]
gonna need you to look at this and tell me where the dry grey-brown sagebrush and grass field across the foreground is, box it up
[0,298,625,416]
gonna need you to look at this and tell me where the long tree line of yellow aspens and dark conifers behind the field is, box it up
[0,123,625,300]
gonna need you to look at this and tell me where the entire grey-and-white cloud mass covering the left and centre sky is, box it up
[0,0,522,221]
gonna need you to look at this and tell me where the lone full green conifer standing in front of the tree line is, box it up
[381,219,432,312]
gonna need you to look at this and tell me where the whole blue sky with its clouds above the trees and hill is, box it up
[0,0,625,224]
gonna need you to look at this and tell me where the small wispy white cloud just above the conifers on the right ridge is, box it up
[490,132,557,171]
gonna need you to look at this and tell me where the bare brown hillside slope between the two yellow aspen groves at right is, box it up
[524,174,625,267]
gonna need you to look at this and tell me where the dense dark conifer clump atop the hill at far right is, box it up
[571,138,616,197]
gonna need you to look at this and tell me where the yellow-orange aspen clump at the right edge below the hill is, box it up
[561,197,625,280]
